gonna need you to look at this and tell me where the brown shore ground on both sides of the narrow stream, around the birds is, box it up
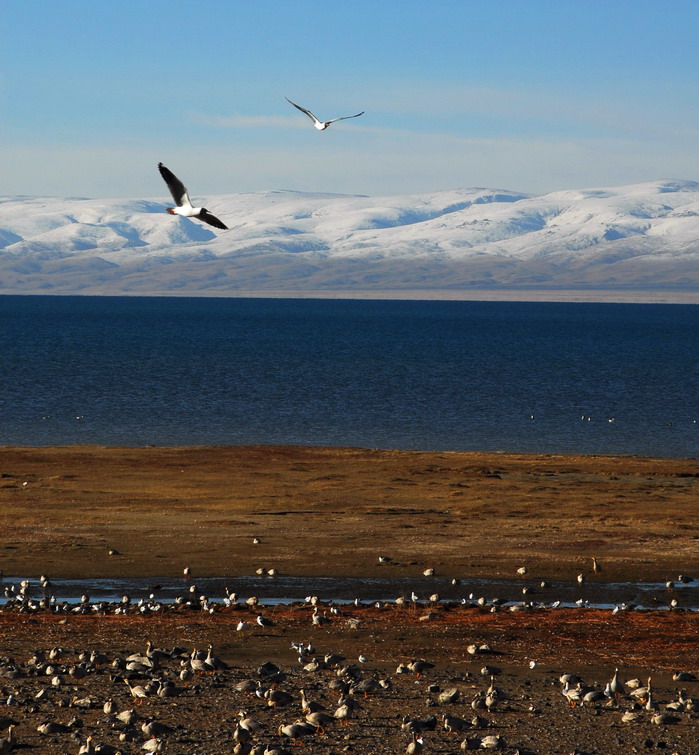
[0,447,699,755]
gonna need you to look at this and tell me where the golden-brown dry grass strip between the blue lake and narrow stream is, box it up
[0,446,699,581]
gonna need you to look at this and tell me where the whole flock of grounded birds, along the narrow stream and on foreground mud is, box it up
[0,556,699,755]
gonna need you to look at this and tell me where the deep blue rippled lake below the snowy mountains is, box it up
[0,296,699,457]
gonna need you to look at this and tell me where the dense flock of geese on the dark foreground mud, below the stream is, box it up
[0,641,699,755]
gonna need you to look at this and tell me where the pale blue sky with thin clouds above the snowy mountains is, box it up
[0,0,699,197]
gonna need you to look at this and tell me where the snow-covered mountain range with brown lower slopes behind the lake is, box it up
[0,180,699,296]
